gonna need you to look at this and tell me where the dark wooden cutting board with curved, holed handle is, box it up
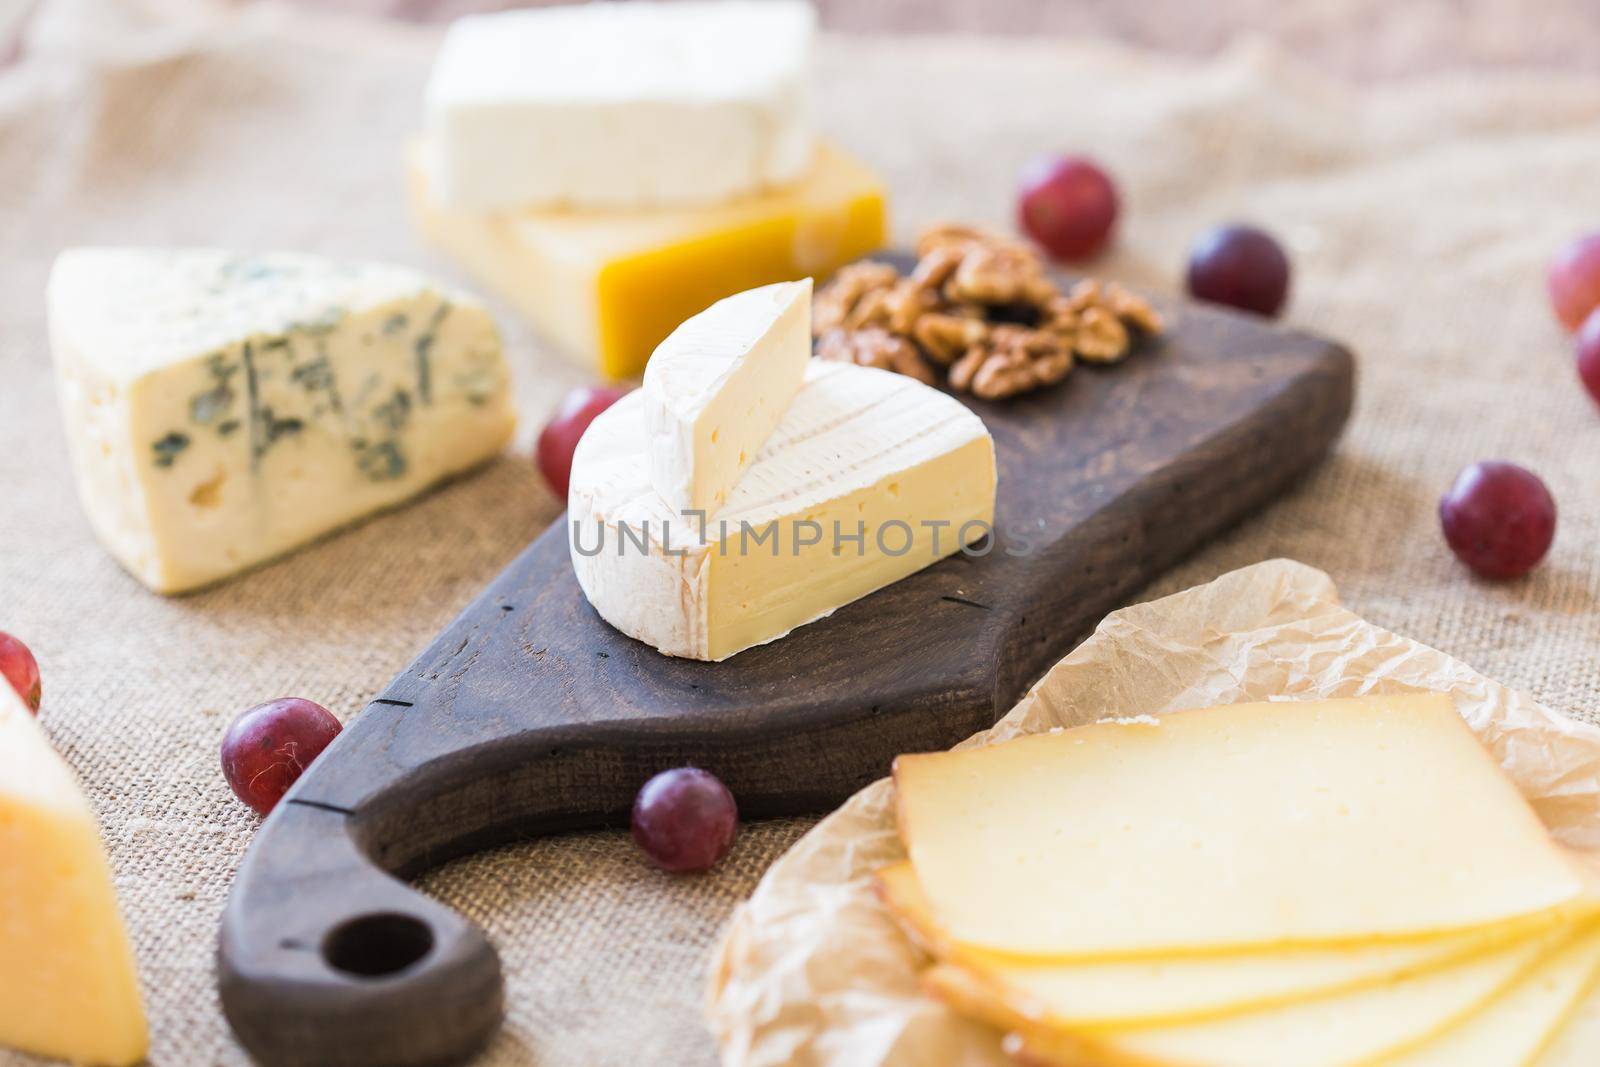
[218,262,1354,1067]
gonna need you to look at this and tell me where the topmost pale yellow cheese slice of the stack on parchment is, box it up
[894,694,1589,958]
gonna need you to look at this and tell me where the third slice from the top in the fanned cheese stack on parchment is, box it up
[925,928,1573,1067]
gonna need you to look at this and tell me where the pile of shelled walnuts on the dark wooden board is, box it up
[813,224,1162,400]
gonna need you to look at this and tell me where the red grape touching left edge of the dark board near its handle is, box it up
[222,696,341,814]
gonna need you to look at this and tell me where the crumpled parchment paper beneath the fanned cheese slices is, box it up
[707,560,1600,1067]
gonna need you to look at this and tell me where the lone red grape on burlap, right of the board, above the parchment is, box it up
[1438,461,1555,577]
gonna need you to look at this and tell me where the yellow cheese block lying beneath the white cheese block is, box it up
[411,144,886,378]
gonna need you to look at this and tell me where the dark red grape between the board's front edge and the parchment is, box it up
[634,766,739,873]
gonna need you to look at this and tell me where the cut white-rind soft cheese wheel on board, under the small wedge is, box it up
[568,360,995,659]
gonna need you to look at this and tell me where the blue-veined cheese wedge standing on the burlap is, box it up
[48,248,514,593]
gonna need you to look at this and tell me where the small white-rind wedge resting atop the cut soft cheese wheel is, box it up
[643,278,811,517]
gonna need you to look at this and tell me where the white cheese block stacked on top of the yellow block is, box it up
[426,0,816,211]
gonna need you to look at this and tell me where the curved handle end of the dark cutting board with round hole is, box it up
[218,803,504,1067]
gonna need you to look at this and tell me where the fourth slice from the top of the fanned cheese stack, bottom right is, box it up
[1384,928,1600,1067]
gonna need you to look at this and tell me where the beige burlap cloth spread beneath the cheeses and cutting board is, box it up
[0,0,1600,1067]
